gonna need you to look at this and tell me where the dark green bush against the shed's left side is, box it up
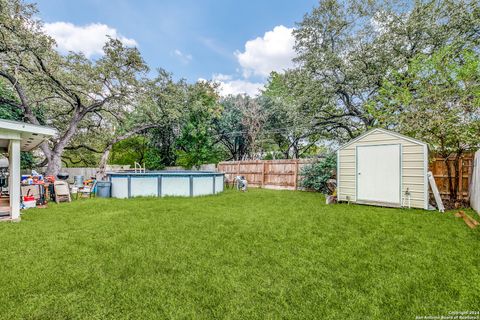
[300,153,337,194]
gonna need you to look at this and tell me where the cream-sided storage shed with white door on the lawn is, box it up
[337,128,428,209]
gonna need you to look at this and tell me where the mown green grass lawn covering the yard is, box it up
[0,190,480,320]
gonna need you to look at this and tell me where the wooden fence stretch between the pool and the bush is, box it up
[217,159,315,190]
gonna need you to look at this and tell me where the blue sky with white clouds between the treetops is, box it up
[36,0,316,93]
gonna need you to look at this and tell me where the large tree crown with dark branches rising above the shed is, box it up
[294,0,480,140]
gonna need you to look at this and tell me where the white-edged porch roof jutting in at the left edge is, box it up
[0,119,57,151]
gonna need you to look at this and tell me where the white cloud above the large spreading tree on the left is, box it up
[44,22,138,58]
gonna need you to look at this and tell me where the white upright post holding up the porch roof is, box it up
[8,140,20,220]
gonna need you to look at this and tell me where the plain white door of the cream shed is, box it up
[357,144,400,205]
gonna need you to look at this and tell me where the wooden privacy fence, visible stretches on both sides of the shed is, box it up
[217,153,473,199]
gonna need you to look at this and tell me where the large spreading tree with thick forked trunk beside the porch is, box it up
[0,0,147,175]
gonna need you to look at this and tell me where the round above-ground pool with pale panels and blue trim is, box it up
[107,171,224,198]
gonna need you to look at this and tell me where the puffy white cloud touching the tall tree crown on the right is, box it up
[235,25,295,78]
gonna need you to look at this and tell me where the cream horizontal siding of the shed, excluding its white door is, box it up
[337,130,428,208]
